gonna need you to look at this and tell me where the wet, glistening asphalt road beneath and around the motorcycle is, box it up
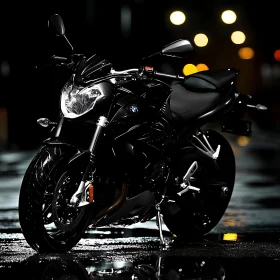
[0,128,280,280]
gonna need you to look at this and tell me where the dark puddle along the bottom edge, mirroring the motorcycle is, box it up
[7,252,280,280]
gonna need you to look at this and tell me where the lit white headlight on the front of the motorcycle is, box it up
[60,80,103,118]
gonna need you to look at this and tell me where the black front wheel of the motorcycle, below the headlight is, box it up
[18,147,95,253]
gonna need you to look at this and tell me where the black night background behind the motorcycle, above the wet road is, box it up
[0,0,280,151]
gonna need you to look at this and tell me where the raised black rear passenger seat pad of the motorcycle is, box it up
[182,68,239,91]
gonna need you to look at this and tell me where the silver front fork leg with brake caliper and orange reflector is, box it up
[70,116,109,207]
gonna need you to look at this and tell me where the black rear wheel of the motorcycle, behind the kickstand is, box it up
[162,130,236,240]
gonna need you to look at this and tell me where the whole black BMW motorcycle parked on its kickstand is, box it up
[19,14,266,252]
